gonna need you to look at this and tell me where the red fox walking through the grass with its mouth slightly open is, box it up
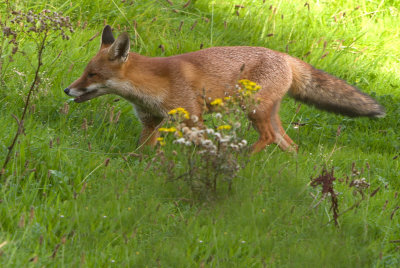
[64,25,385,152]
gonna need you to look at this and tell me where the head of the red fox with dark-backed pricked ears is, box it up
[64,25,130,103]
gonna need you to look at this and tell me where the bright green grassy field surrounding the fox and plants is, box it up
[0,0,400,267]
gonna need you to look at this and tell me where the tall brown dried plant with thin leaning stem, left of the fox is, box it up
[0,4,74,178]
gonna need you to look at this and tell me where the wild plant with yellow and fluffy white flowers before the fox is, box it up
[153,80,260,197]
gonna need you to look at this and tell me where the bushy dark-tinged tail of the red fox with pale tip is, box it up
[288,57,385,117]
